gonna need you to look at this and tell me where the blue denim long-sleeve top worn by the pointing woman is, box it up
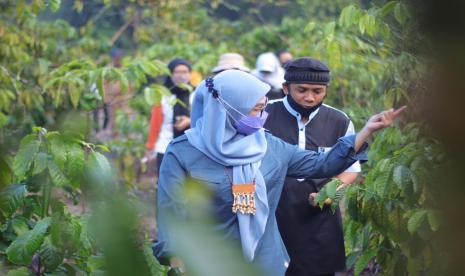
[153,133,367,275]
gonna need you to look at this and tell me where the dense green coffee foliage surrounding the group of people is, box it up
[0,0,446,275]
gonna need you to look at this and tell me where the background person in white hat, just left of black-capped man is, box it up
[252,52,284,100]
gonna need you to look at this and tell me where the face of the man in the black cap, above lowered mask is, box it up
[283,83,326,108]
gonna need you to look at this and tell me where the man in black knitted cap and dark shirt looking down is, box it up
[265,57,360,275]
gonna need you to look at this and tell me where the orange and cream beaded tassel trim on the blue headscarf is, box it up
[232,183,257,215]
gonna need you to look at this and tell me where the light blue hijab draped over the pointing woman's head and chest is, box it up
[186,70,270,261]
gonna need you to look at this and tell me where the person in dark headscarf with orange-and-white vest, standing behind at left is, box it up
[145,58,192,174]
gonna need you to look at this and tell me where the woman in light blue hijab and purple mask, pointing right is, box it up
[154,70,404,275]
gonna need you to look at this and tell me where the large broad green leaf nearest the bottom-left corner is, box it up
[6,218,51,265]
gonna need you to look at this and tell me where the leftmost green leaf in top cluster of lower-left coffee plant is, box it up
[13,134,40,180]
